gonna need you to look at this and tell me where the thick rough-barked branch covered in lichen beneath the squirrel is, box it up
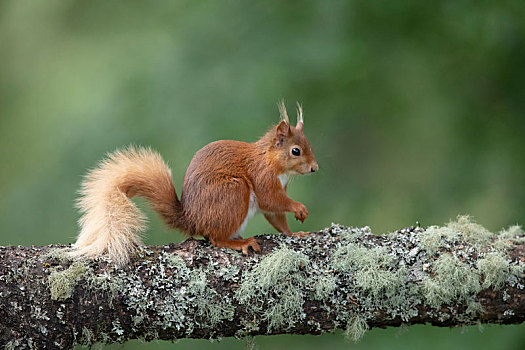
[0,220,525,349]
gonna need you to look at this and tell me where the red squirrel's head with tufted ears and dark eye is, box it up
[270,101,319,175]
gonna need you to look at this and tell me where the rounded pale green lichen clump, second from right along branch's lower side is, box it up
[421,253,481,309]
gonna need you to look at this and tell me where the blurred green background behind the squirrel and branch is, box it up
[0,0,525,349]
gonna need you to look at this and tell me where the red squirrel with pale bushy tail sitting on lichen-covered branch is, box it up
[73,102,319,265]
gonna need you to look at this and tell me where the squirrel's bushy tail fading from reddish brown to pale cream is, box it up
[73,147,182,265]
